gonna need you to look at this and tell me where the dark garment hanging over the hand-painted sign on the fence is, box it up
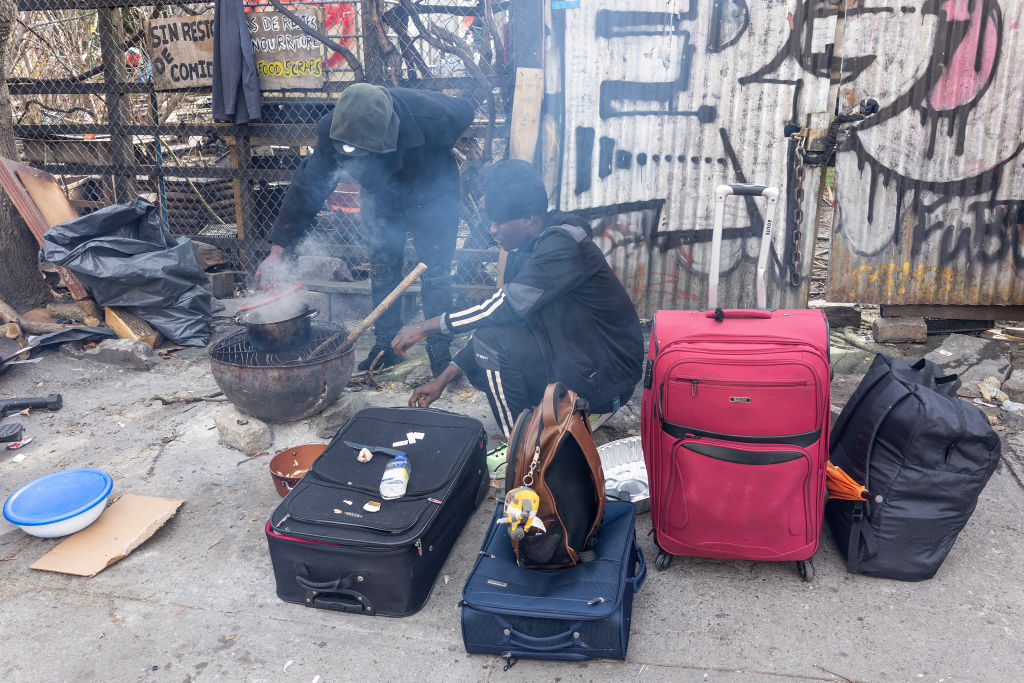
[213,0,262,124]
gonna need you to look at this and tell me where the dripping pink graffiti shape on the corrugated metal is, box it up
[928,0,999,112]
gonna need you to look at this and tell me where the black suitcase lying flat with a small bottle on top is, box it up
[266,408,489,616]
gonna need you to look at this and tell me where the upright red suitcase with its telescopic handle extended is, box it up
[641,185,830,581]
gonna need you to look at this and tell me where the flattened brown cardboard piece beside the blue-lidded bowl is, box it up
[29,494,184,577]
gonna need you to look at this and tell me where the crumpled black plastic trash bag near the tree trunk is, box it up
[43,199,212,346]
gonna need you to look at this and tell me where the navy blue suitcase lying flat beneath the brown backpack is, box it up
[461,501,647,666]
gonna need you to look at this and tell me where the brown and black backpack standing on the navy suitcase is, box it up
[505,382,604,569]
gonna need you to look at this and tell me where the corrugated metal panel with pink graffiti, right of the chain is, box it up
[828,0,1024,305]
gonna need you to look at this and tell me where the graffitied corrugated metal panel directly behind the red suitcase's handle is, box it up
[542,0,838,315]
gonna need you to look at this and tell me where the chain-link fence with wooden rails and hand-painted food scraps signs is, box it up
[7,0,515,294]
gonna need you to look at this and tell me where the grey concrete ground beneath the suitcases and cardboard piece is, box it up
[0,317,1024,683]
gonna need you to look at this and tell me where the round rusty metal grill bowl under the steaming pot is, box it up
[208,323,352,422]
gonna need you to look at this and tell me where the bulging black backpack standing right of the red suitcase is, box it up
[825,354,999,581]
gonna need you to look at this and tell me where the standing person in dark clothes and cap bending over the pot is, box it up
[256,83,474,375]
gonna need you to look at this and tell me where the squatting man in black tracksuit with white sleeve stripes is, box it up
[391,161,644,444]
